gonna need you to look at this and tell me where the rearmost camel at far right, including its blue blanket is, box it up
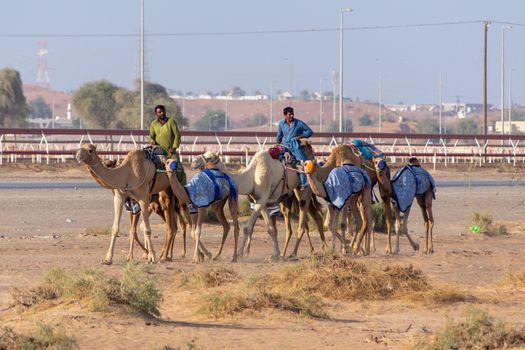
[384,157,435,254]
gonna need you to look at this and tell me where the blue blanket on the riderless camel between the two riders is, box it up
[184,169,237,208]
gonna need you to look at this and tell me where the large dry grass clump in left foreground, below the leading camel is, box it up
[11,263,162,316]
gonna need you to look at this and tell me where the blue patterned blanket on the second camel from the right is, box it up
[323,165,372,210]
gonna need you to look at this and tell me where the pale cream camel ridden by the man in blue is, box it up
[192,140,325,259]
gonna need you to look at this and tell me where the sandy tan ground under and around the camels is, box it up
[0,165,525,349]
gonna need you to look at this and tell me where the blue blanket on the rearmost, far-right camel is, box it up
[392,165,436,213]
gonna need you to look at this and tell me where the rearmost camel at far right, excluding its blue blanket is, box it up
[382,158,434,254]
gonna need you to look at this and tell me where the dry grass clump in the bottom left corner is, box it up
[0,324,78,350]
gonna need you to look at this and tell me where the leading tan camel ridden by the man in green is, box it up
[76,144,177,262]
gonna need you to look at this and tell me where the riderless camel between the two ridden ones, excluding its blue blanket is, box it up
[166,159,239,263]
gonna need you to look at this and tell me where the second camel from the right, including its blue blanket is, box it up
[305,145,373,254]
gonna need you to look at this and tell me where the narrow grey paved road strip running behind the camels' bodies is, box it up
[0,180,525,190]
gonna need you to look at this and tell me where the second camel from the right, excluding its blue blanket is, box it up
[306,145,373,254]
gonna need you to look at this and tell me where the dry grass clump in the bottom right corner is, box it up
[414,307,525,350]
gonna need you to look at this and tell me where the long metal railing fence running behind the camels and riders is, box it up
[0,128,525,166]
